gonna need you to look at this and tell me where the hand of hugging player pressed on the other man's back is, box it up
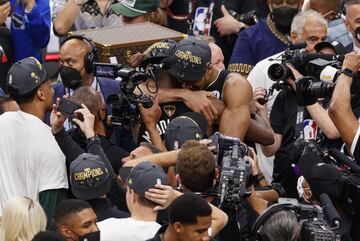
[184,90,218,126]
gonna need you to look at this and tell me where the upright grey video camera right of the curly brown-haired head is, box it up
[213,132,251,210]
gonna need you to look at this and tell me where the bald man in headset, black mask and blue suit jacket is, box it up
[53,35,136,152]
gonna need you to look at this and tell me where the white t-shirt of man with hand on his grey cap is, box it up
[97,218,161,241]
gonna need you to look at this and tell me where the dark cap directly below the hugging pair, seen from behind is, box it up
[164,112,207,151]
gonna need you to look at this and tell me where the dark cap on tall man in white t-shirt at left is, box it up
[7,57,46,96]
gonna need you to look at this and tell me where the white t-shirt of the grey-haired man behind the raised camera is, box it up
[247,52,284,183]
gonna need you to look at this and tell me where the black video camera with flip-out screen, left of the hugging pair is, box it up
[94,63,162,126]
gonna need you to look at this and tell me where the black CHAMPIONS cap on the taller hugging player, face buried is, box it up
[168,37,211,82]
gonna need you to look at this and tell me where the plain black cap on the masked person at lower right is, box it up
[299,153,345,200]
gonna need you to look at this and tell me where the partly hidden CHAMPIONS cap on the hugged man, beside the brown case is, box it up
[140,39,176,68]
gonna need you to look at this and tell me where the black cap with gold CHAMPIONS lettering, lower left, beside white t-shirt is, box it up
[70,153,111,200]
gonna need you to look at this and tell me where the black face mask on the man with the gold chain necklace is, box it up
[272,7,299,34]
